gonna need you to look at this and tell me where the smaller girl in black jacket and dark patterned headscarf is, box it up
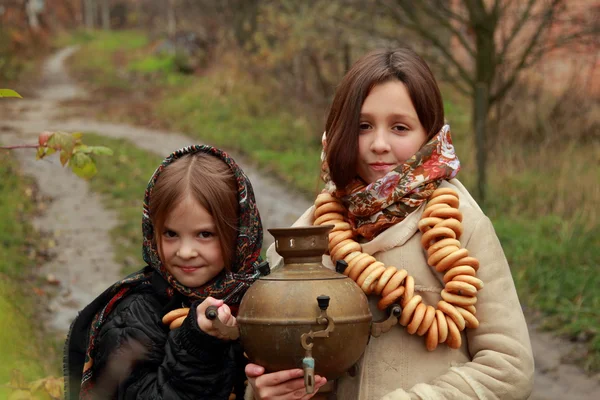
[65,146,262,399]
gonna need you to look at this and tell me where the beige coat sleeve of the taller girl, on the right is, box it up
[383,217,534,400]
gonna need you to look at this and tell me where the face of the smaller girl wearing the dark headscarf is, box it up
[160,196,224,288]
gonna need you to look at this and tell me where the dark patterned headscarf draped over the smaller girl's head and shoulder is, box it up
[65,145,263,399]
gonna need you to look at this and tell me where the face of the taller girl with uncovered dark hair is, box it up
[356,80,427,184]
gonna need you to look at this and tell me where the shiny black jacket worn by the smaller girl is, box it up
[96,297,234,400]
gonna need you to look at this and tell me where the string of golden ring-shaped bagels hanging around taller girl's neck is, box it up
[313,188,483,351]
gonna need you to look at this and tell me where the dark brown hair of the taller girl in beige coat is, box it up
[325,48,444,189]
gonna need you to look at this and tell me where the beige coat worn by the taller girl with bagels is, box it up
[249,179,534,400]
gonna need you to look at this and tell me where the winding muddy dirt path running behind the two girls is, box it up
[0,48,600,400]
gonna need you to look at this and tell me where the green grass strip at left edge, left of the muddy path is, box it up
[0,151,60,399]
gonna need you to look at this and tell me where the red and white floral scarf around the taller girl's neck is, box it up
[321,125,460,240]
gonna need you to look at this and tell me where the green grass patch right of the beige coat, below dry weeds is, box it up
[494,215,600,371]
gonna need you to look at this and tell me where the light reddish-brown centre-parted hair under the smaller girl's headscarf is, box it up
[148,153,239,271]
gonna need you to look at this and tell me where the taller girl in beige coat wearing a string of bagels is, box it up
[251,49,534,400]
